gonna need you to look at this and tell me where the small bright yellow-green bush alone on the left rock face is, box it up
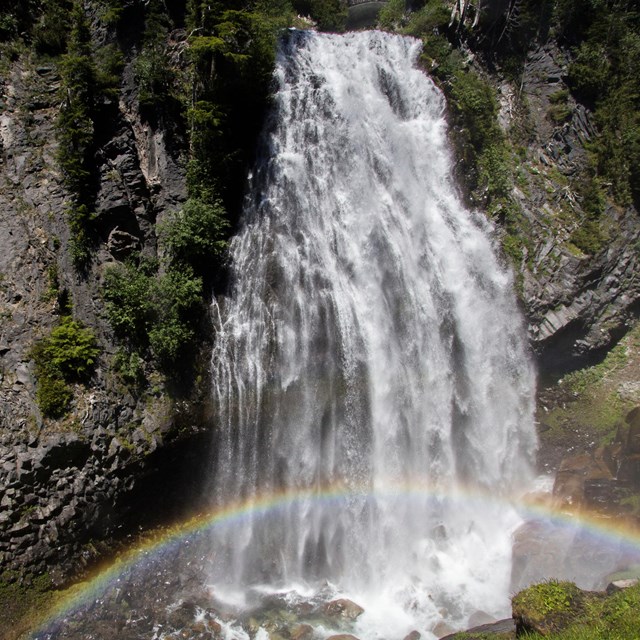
[30,316,100,418]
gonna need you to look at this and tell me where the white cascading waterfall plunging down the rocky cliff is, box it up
[211,32,535,638]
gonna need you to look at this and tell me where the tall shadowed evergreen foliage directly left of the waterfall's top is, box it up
[187,0,292,218]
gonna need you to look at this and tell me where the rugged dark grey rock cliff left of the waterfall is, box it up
[0,45,208,582]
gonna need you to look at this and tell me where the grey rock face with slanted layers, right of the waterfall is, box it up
[501,45,640,373]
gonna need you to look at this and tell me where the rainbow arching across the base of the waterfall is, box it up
[30,482,640,637]
